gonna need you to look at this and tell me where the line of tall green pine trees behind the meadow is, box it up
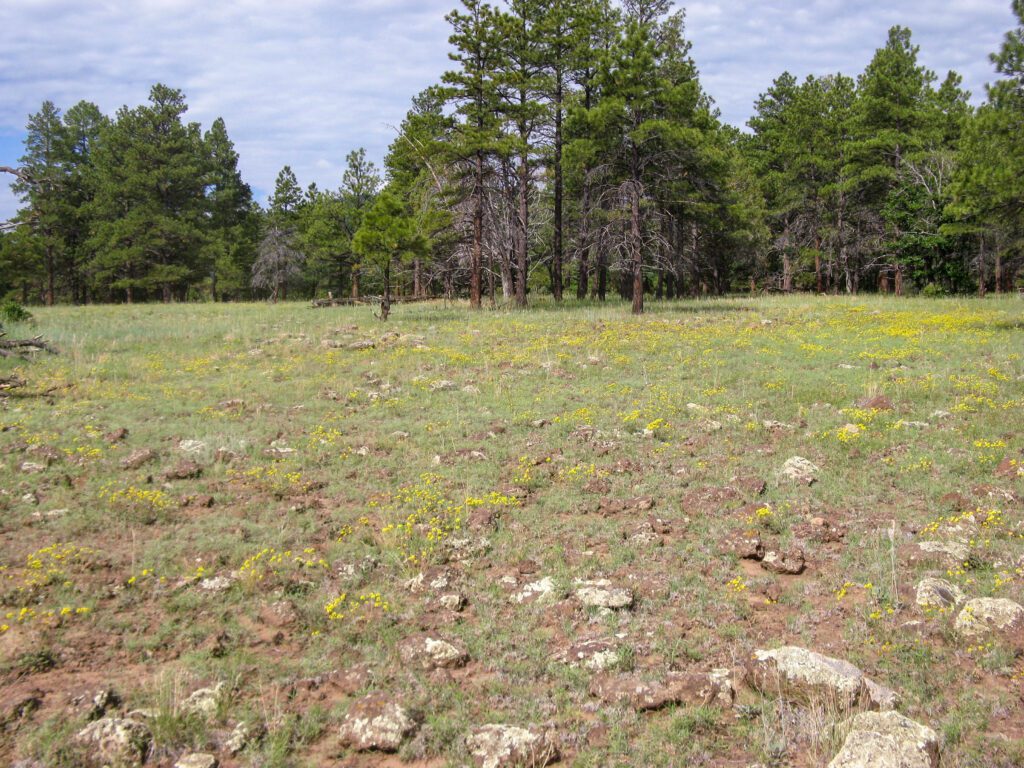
[0,0,1024,312]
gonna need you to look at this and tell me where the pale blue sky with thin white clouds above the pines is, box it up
[0,0,1016,221]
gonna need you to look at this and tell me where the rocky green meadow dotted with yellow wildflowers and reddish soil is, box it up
[0,297,1024,768]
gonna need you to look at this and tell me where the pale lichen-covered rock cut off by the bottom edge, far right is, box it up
[828,712,939,768]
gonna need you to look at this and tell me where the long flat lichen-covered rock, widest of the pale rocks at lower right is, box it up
[748,646,898,710]
